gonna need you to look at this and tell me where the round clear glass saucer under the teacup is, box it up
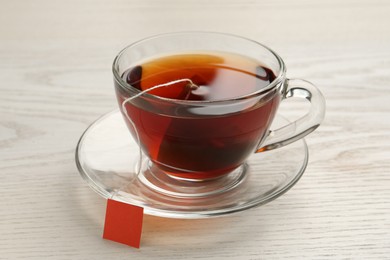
[76,110,308,219]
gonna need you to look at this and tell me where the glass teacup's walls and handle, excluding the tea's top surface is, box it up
[113,32,325,189]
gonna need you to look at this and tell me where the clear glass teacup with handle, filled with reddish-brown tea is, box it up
[113,32,325,187]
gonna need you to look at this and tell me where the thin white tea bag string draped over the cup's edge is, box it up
[111,78,199,199]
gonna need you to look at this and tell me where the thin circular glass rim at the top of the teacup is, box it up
[112,31,286,104]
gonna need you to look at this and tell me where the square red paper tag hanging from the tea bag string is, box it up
[103,199,144,248]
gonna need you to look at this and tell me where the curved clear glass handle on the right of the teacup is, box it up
[256,79,325,153]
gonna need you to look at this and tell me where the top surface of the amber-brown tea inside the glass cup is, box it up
[123,52,275,100]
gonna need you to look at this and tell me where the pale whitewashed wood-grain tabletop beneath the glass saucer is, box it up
[0,0,390,259]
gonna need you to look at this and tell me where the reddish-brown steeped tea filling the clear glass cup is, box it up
[117,52,281,179]
